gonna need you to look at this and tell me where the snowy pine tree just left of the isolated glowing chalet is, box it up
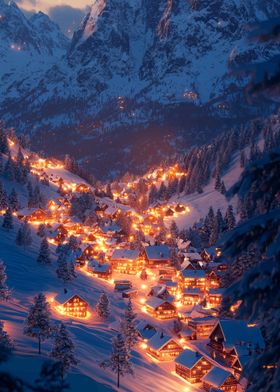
[24,293,52,354]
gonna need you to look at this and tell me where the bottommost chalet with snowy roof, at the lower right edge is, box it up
[202,366,238,392]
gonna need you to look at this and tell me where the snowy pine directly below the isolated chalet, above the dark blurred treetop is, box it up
[50,323,78,379]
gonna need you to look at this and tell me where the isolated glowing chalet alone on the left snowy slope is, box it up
[54,290,88,318]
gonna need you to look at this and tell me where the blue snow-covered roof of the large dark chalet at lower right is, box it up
[214,320,265,349]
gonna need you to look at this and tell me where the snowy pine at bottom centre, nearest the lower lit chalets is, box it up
[100,334,133,388]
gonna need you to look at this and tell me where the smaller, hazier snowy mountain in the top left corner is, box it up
[0,0,68,100]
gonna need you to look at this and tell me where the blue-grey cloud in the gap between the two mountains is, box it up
[48,5,86,36]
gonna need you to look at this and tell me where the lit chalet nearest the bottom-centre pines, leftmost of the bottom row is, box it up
[147,332,183,361]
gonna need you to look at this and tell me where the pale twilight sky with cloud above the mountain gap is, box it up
[16,0,89,35]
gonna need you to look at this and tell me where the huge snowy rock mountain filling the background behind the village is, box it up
[0,0,280,176]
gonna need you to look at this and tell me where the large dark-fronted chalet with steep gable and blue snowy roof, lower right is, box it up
[209,320,265,365]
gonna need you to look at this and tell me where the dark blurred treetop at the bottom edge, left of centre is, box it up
[35,361,69,392]
